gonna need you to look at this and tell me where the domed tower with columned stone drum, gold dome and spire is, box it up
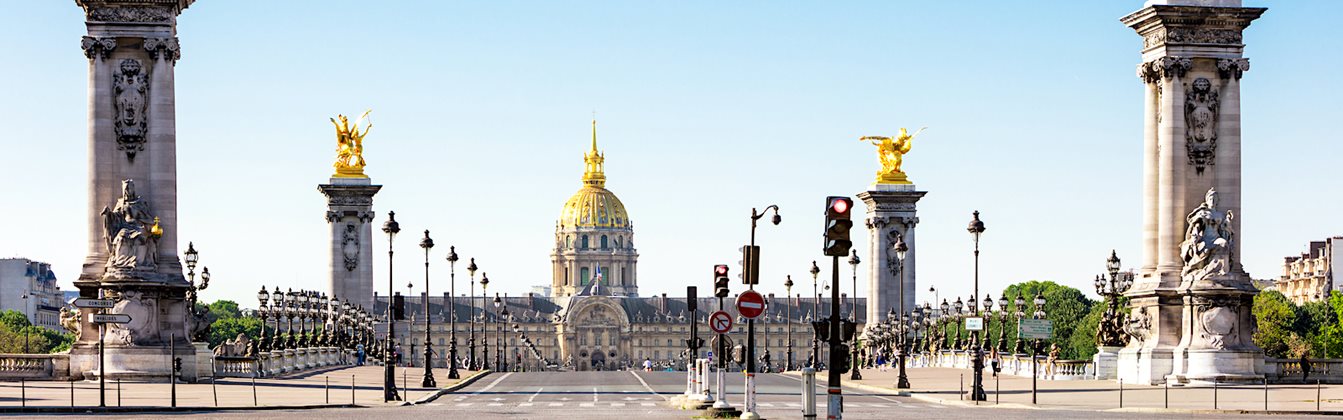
[551,119,639,297]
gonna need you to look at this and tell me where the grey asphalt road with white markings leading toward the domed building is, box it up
[23,372,1343,420]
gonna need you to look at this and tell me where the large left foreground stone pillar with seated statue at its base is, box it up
[70,0,203,380]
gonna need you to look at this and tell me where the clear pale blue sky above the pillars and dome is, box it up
[0,0,1343,306]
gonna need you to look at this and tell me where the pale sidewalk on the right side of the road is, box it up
[811,368,1343,412]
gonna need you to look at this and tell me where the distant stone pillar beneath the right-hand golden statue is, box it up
[858,184,928,325]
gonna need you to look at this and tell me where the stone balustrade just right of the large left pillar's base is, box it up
[215,348,355,377]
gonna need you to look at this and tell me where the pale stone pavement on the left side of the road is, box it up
[0,366,475,409]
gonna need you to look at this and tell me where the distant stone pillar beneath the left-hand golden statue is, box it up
[317,177,383,310]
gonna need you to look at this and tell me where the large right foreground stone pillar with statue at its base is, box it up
[1119,0,1265,384]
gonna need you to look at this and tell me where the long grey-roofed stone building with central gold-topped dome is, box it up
[375,121,866,370]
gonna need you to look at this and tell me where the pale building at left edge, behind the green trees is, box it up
[0,258,64,331]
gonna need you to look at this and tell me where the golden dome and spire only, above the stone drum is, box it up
[560,119,630,228]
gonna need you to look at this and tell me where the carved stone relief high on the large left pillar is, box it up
[111,59,149,161]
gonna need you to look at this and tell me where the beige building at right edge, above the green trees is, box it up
[1276,236,1343,305]
